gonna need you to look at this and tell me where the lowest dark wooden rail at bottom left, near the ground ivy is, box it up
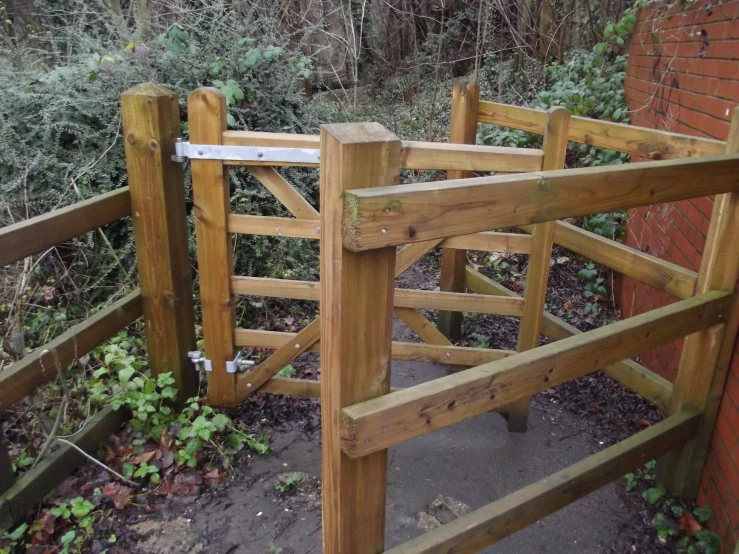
[0,406,128,530]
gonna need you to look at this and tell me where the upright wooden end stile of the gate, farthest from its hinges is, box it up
[504,108,570,433]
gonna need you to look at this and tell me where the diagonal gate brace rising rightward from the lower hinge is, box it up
[236,235,440,399]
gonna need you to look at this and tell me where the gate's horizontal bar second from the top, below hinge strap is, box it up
[228,214,531,254]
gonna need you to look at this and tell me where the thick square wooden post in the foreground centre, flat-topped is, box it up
[321,123,400,554]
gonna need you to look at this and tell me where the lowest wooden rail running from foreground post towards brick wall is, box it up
[386,411,698,554]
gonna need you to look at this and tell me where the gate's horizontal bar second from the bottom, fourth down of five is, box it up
[234,328,515,366]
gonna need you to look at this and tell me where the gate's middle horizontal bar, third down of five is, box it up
[231,277,523,317]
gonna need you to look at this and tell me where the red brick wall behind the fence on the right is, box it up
[619,0,739,553]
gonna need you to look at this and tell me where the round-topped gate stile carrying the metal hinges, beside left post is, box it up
[187,88,238,407]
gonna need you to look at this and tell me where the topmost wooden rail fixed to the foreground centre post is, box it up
[344,154,739,251]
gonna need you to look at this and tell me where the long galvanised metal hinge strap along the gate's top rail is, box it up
[172,139,321,164]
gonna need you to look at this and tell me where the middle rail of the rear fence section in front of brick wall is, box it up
[524,221,698,300]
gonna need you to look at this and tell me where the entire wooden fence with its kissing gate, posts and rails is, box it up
[0,77,739,554]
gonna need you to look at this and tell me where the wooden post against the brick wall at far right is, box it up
[659,108,739,498]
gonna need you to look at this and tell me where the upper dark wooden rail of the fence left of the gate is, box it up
[0,187,131,267]
